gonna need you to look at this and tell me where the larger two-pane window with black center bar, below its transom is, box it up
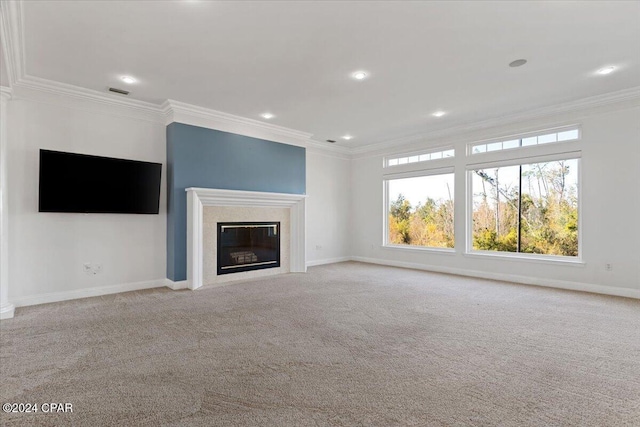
[470,158,579,257]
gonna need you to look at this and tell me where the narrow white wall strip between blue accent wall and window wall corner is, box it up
[306,149,351,265]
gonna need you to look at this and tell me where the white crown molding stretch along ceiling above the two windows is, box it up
[350,86,640,157]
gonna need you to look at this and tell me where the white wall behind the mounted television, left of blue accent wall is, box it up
[8,93,166,306]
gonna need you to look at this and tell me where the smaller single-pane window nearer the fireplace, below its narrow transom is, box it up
[386,173,454,248]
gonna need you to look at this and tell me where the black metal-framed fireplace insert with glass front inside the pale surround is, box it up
[217,222,280,275]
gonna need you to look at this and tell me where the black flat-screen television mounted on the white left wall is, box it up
[39,150,162,214]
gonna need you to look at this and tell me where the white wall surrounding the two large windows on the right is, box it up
[351,105,640,297]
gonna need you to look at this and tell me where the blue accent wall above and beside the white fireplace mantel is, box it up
[167,123,306,282]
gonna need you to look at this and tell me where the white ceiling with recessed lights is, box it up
[12,0,640,147]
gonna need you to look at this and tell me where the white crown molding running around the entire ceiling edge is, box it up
[0,0,640,157]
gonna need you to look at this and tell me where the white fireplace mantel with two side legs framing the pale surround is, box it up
[186,187,307,289]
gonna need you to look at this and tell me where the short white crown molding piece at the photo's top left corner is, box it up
[0,0,25,86]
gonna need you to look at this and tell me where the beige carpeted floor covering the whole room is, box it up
[0,263,640,427]
